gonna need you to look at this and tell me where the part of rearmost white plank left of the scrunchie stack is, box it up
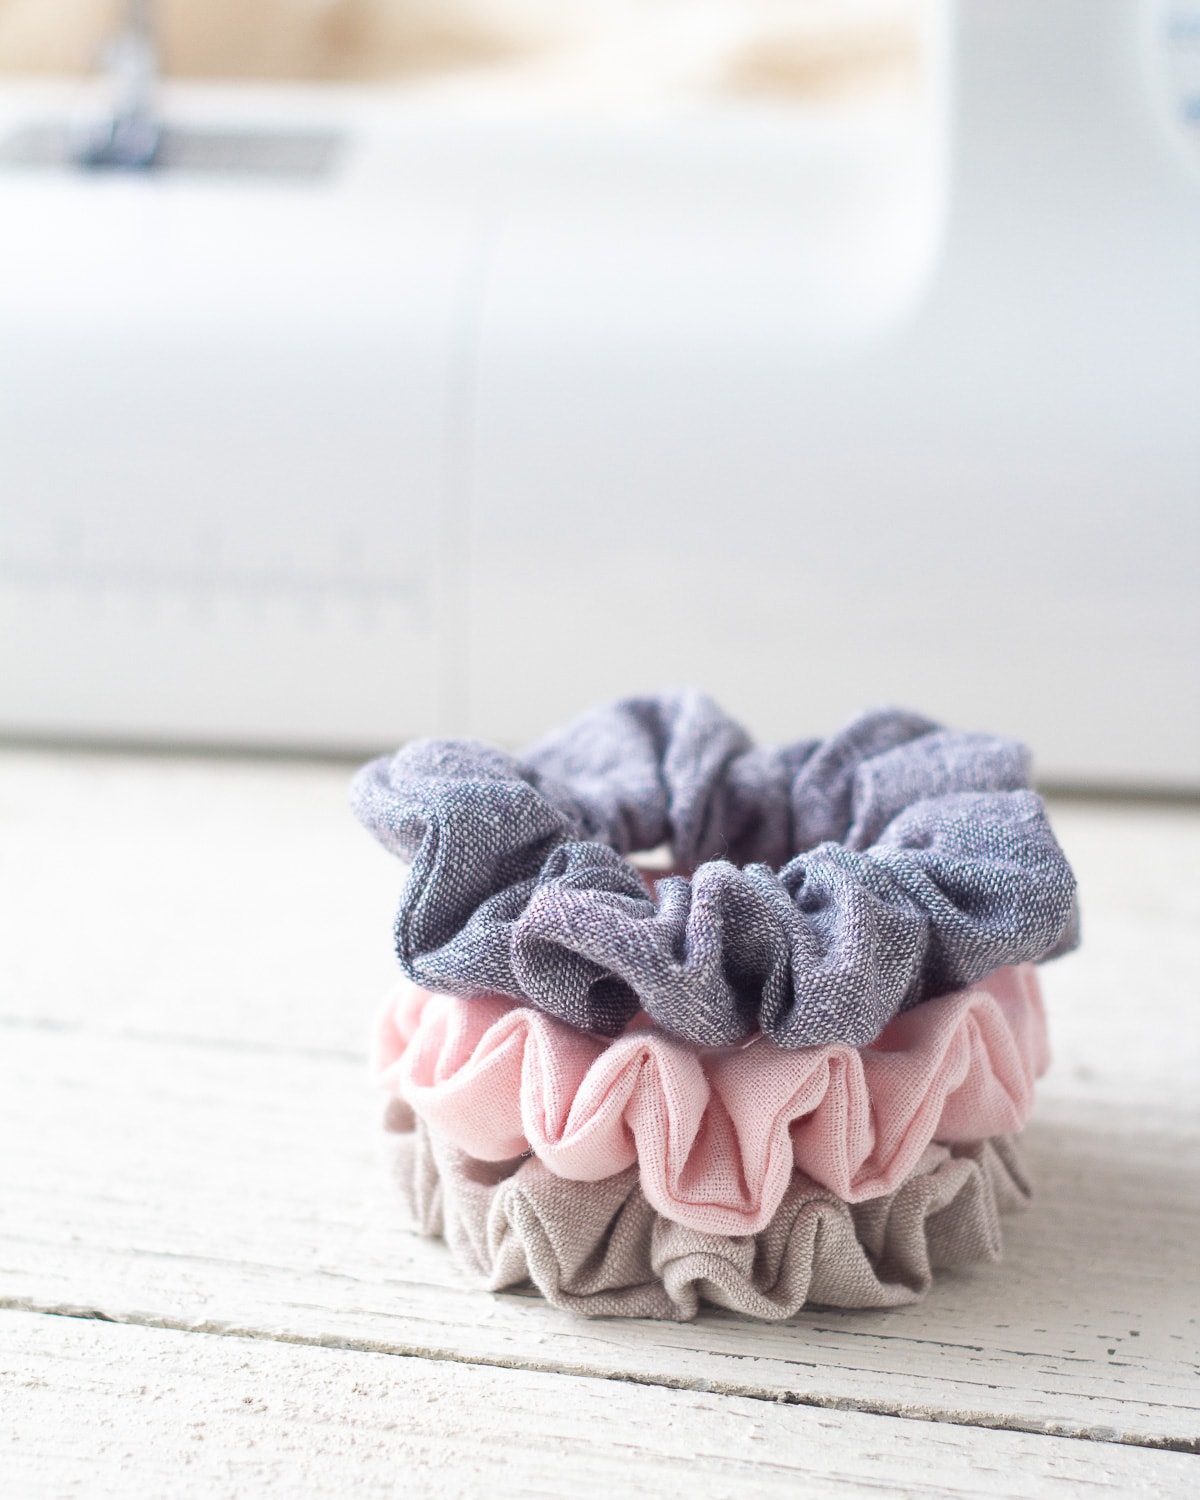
[0,749,401,1053]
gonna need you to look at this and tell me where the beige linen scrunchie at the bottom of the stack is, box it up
[389,1109,1029,1322]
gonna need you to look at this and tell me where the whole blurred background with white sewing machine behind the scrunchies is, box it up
[0,0,1200,792]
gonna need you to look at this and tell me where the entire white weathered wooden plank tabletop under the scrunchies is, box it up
[0,749,1200,1500]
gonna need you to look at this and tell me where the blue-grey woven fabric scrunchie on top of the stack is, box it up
[353,693,1077,1047]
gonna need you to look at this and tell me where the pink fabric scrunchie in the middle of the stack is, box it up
[377,965,1049,1235]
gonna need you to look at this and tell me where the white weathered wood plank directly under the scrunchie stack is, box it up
[0,1029,1200,1446]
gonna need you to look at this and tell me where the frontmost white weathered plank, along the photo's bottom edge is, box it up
[0,1313,1200,1500]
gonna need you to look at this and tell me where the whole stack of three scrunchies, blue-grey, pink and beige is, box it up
[354,693,1079,1319]
